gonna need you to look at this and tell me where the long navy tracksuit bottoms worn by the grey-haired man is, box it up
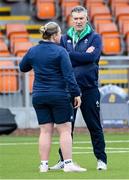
[59,88,107,163]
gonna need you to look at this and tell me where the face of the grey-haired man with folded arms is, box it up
[72,11,87,32]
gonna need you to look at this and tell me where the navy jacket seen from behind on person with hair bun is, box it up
[19,41,80,97]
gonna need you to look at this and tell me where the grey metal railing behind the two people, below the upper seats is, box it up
[0,56,129,107]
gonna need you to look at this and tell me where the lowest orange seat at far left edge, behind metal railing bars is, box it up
[0,60,18,93]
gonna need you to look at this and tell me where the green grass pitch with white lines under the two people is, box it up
[0,133,129,179]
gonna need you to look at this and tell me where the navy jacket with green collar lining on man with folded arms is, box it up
[61,31,102,91]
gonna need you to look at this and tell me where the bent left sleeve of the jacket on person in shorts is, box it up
[19,49,32,72]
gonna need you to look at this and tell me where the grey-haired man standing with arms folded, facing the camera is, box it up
[50,6,107,170]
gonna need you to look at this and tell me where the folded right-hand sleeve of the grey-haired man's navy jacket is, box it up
[69,35,102,67]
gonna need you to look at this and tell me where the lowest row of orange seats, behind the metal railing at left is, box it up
[0,60,34,94]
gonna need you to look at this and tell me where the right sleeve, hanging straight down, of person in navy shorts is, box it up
[61,49,80,97]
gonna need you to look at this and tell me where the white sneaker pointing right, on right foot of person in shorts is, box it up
[64,163,87,172]
